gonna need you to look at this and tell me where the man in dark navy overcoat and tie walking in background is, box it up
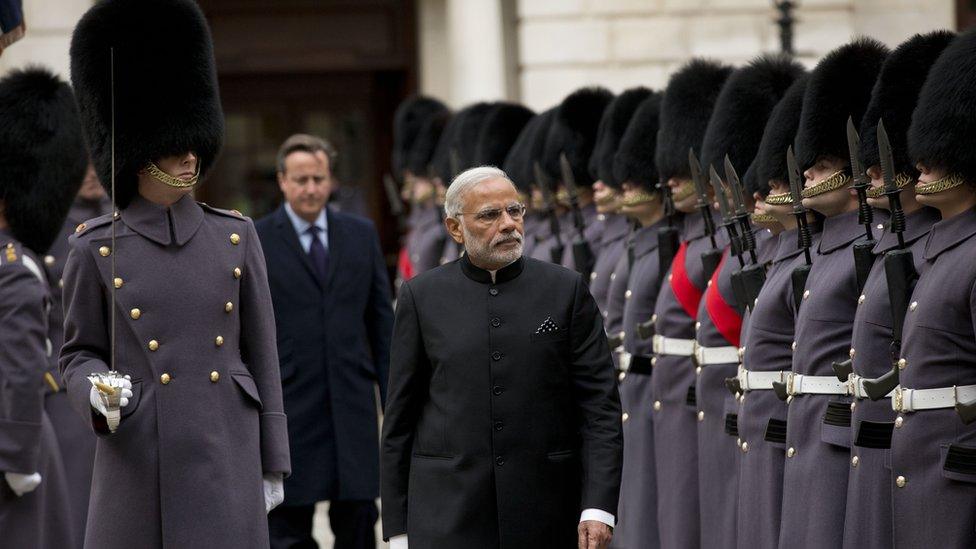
[255,134,393,548]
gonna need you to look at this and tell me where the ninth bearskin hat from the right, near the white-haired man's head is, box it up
[542,87,613,187]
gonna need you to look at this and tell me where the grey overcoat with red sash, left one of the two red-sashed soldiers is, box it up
[651,214,724,548]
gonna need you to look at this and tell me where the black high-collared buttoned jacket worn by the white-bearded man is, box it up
[381,256,623,549]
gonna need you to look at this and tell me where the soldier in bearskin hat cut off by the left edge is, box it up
[0,68,88,549]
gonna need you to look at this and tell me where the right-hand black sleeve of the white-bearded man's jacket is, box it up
[571,277,624,515]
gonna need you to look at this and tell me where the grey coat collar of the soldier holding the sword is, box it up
[122,194,203,246]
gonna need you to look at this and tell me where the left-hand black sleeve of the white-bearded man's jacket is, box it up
[380,283,428,540]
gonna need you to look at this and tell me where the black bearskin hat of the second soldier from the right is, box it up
[860,30,956,176]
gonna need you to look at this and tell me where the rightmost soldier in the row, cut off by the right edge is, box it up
[889,30,976,547]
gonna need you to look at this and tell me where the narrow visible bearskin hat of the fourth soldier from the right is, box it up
[743,75,810,196]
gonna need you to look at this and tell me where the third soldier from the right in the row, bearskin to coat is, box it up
[779,39,888,548]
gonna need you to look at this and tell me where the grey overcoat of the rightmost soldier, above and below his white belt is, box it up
[889,210,976,548]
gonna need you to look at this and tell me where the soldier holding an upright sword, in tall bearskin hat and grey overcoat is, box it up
[61,0,290,548]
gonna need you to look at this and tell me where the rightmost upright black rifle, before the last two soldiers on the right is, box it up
[864,122,920,402]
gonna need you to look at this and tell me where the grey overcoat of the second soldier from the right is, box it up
[844,208,939,549]
